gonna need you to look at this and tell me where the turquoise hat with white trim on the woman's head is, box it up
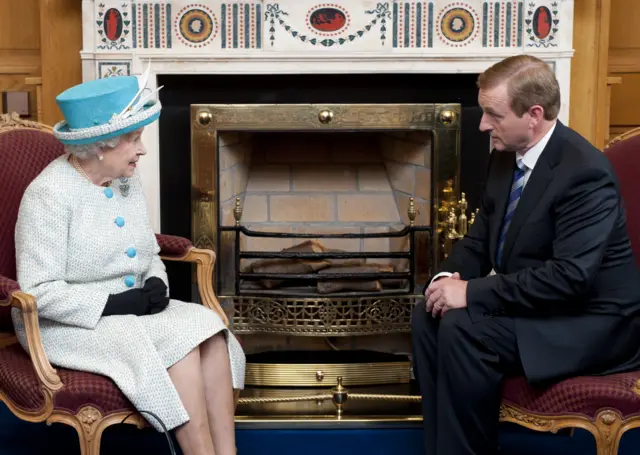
[53,69,162,144]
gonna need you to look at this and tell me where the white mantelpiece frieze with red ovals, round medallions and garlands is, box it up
[87,0,573,55]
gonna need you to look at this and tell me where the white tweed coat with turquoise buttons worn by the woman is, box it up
[12,155,245,430]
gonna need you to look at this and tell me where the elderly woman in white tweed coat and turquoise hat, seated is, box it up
[13,76,245,455]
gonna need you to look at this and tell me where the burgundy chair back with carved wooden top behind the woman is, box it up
[0,114,64,332]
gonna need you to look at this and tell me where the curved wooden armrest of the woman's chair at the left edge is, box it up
[0,275,63,421]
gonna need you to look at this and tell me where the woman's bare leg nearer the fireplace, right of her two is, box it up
[200,333,236,455]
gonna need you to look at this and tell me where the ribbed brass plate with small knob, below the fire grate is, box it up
[245,361,411,387]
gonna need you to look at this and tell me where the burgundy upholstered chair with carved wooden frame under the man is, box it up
[500,128,640,455]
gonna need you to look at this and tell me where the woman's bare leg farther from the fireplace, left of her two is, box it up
[168,348,217,455]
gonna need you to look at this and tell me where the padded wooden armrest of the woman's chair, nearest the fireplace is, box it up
[156,234,229,326]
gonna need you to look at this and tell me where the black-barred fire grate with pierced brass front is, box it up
[220,210,432,336]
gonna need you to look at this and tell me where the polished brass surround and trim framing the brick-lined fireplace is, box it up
[191,104,460,415]
